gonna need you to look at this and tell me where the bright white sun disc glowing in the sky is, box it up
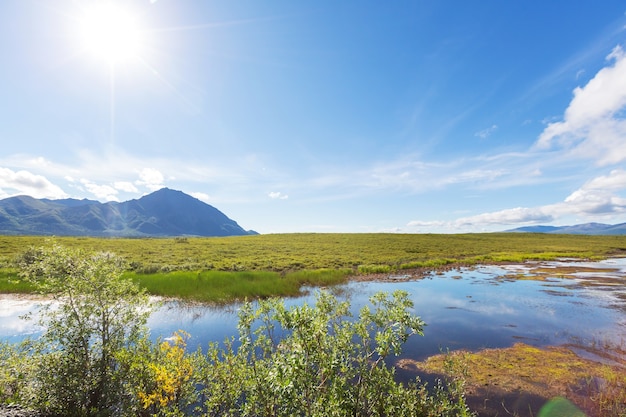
[80,3,143,65]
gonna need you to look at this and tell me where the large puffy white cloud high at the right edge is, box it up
[536,46,626,165]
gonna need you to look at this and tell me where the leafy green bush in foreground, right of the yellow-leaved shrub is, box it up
[196,291,470,416]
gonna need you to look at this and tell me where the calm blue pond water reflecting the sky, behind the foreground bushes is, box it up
[0,259,626,360]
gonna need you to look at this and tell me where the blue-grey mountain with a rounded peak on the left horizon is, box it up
[0,188,257,237]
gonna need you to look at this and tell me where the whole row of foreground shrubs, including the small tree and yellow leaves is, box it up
[0,244,470,416]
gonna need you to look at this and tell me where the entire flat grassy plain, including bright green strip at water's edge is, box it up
[0,233,626,302]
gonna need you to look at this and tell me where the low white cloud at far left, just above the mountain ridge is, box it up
[0,167,67,199]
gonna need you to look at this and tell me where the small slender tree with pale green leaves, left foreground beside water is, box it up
[20,242,149,416]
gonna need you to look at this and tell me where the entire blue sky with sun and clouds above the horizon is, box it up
[0,0,626,233]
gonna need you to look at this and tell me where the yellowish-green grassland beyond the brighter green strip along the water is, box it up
[0,233,626,272]
